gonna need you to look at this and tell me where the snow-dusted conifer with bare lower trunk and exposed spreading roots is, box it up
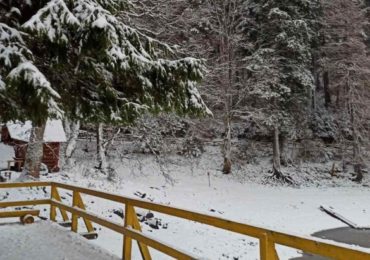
[245,0,320,182]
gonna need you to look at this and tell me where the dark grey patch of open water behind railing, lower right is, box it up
[292,227,370,260]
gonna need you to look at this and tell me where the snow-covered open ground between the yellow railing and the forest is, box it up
[0,143,370,260]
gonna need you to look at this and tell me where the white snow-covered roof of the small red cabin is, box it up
[6,120,67,143]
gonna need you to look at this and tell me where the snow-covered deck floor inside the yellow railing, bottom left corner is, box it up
[0,221,120,260]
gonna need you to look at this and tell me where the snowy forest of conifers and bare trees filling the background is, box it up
[0,0,370,185]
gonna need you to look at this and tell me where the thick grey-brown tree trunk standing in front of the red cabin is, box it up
[23,124,46,178]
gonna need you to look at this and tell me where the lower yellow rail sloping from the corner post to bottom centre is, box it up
[51,200,197,260]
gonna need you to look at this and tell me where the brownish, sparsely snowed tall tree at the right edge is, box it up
[321,0,370,182]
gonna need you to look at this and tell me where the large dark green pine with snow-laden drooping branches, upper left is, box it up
[0,0,209,177]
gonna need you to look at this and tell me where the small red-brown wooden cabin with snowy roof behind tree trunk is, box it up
[1,120,66,172]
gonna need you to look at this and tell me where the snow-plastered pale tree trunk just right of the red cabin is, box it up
[63,120,81,167]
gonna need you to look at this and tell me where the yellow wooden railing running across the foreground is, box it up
[0,182,370,260]
